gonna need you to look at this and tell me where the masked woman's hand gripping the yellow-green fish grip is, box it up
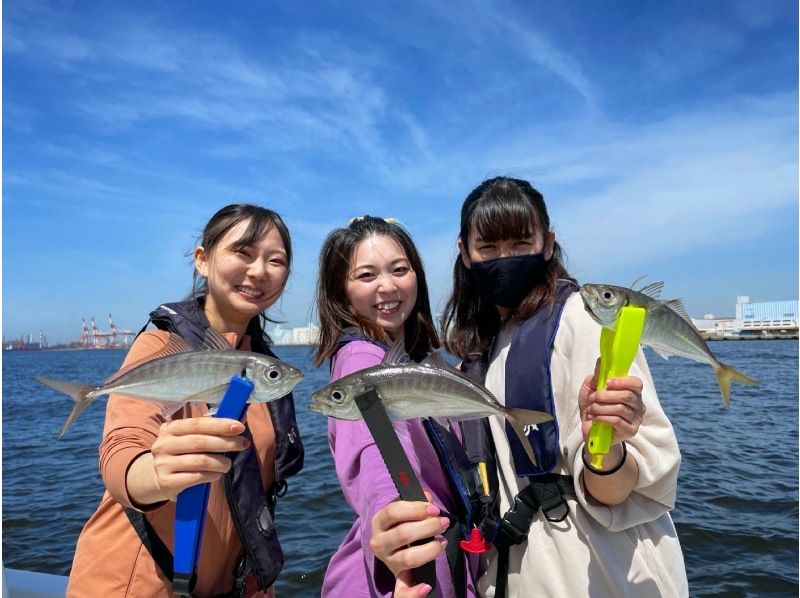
[578,360,645,444]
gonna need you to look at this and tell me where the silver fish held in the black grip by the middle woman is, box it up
[309,343,553,463]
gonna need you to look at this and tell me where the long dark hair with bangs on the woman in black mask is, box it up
[441,177,574,359]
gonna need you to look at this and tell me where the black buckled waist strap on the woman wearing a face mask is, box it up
[492,474,575,598]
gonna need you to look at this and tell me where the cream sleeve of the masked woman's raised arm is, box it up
[553,294,681,531]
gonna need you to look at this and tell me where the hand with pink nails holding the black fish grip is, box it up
[370,492,450,598]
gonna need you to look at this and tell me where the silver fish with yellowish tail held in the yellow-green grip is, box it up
[580,279,758,407]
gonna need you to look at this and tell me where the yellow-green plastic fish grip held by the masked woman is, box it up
[586,306,646,469]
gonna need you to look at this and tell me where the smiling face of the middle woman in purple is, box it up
[346,235,417,340]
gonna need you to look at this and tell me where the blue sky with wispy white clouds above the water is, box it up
[2,0,798,342]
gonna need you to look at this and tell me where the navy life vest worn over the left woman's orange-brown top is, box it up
[125,297,304,596]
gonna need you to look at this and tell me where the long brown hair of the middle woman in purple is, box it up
[314,216,439,366]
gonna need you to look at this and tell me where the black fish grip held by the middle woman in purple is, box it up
[355,388,438,597]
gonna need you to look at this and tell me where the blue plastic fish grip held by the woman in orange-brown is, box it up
[172,375,253,596]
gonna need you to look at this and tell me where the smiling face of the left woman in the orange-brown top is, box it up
[194,220,289,334]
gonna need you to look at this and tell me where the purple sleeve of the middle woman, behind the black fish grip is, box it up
[328,341,419,596]
